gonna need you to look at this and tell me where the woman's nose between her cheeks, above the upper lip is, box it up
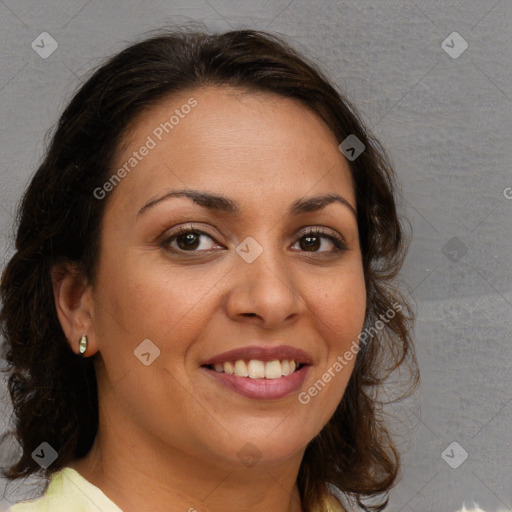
[225,236,306,329]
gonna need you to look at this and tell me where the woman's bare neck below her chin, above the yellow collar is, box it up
[69,421,302,512]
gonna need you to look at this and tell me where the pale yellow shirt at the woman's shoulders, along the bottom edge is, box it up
[7,467,343,512]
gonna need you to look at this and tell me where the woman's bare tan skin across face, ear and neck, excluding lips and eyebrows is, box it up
[53,86,366,512]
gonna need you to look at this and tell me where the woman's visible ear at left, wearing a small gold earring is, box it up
[51,263,98,357]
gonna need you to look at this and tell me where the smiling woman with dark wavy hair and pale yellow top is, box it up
[1,26,418,512]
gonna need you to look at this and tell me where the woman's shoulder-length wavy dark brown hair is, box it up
[0,26,419,512]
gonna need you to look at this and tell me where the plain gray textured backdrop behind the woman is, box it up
[0,0,512,512]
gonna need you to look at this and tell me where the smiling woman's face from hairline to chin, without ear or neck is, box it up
[85,87,365,465]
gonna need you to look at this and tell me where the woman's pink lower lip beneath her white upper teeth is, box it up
[201,365,310,400]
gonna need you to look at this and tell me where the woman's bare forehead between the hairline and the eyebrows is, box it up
[107,86,355,216]
